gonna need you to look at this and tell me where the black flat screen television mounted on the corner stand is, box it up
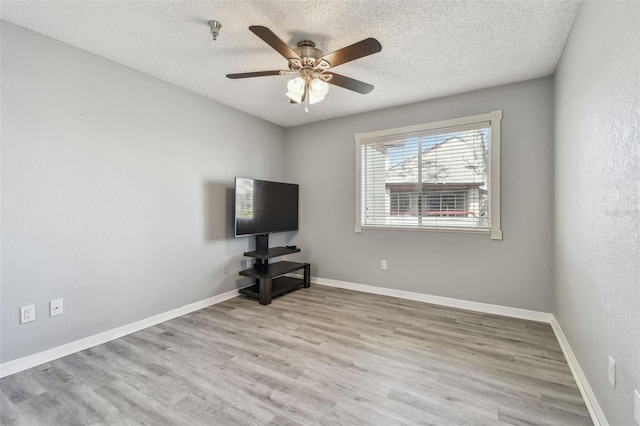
[234,177,298,237]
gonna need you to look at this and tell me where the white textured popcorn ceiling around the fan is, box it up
[0,0,579,127]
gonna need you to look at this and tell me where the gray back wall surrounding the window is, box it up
[286,77,553,312]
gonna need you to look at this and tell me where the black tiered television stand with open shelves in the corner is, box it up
[240,235,311,305]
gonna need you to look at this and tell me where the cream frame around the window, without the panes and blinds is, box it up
[355,110,502,240]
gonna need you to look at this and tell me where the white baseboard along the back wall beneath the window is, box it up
[297,275,553,323]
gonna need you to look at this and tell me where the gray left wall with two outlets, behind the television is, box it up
[0,22,284,362]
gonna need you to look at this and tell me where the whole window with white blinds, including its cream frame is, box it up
[356,111,502,239]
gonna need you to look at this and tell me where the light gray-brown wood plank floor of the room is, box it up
[0,284,593,426]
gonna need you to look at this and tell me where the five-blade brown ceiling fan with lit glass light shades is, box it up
[227,25,382,114]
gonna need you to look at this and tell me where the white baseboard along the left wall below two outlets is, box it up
[0,290,245,378]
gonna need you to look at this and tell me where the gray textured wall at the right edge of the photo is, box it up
[555,1,640,426]
